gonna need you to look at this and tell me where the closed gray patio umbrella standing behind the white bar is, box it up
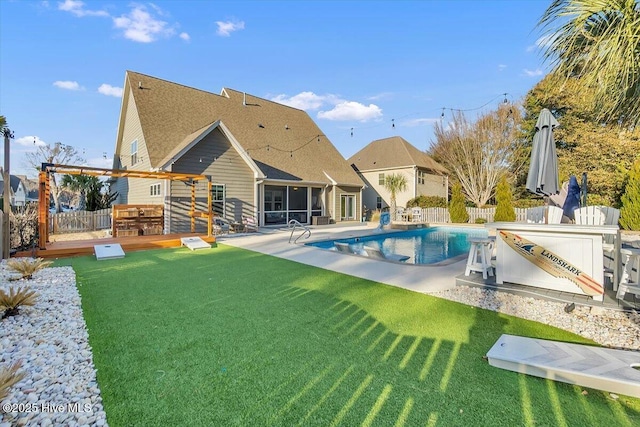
[526,108,560,196]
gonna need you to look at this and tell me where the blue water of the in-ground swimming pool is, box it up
[307,227,488,264]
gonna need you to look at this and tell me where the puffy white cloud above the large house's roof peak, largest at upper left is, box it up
[113,5,175,43]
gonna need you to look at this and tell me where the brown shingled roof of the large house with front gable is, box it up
[116,71,363,186]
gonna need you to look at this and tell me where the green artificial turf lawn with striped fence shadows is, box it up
[57,245,640,426]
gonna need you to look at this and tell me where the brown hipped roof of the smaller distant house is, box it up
[347,136,448,174]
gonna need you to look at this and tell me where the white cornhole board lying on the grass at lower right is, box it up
[487,334,640,397]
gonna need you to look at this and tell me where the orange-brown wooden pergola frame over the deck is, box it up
[38,163,213,249]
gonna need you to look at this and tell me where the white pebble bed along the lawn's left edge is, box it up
[0,261,107,427]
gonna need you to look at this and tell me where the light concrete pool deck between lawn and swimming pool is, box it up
[217,224,466,293]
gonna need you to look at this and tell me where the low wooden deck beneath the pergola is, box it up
[15,233,216,258]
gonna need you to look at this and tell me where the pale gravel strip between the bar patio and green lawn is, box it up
[430,286,640,351]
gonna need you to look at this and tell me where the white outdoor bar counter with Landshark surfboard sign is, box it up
[485,222,620,301]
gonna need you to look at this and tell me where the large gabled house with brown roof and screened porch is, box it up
[111,71,364,233]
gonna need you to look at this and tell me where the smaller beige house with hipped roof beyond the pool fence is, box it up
[347,136,449,213]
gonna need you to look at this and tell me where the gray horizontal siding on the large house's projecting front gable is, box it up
[165,129,255,233]
